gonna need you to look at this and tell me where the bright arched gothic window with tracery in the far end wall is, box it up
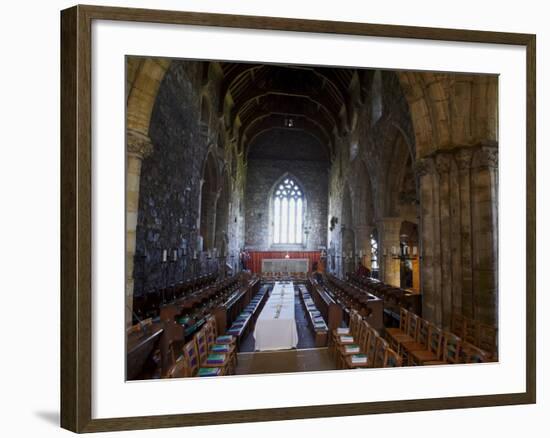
[273,177,304,244]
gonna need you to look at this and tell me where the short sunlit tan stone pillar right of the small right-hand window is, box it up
[376,217,402,287]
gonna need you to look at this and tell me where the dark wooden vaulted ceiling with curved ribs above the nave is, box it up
[218,63,356,161]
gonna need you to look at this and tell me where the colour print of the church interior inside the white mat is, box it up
[127,55,506,381]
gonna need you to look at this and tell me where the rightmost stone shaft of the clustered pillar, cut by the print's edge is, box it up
[471,146,498,324]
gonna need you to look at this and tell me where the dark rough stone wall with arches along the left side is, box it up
[133,61,243,295]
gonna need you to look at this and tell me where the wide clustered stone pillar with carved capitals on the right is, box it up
[416,145,498,329]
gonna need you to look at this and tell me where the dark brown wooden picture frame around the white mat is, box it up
[61,6,536,432]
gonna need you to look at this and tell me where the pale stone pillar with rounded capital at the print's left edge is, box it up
[126,131,153,327]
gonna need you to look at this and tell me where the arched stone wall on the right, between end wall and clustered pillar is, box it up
[328,70,418,278]
